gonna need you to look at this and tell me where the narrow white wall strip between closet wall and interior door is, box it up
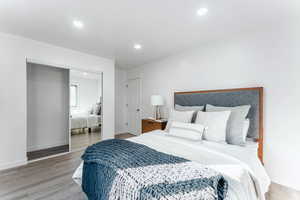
[115,68,127,134]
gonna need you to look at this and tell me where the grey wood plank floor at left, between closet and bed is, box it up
[0,151,86,200]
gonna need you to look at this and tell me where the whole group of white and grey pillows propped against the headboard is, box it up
[166,104,251,146]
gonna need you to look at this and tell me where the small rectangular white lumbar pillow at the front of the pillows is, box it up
[168,121,205,140]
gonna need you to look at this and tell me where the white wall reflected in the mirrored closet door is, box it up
[71,75,101,113]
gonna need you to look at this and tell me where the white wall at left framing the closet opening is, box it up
[0,33,115,169]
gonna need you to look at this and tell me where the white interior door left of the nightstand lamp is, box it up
[127,79,141,135]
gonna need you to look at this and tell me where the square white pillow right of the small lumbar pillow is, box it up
[196,111,231,143]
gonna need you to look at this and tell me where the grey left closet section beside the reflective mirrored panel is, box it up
[27,63,70,160]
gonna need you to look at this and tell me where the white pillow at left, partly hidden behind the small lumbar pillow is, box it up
[165,110,194,131]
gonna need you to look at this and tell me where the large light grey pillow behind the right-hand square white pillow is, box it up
[206,104,251,146]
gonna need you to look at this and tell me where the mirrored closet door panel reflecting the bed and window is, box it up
[70,70,102,151]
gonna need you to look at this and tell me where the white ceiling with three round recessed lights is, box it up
[0,0,300,68]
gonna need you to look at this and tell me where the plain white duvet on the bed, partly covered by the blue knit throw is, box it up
[73,131,270,200]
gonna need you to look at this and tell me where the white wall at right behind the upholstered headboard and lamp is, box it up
[128,25,300,190]
